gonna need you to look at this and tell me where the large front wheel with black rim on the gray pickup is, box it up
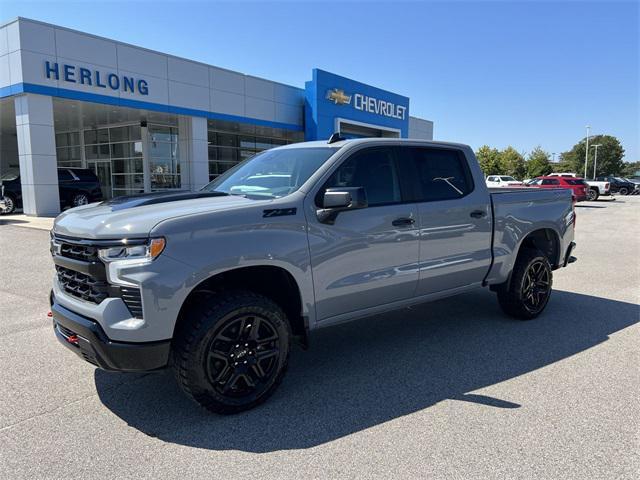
[173,291,291,414]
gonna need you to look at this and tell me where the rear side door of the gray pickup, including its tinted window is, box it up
[400,146,493,296]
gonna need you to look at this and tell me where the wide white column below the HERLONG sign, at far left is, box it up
[14,93,60,216]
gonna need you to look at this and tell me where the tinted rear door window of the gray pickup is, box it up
[411,148,473,201]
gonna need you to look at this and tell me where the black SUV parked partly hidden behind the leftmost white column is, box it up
[0,168,102,213]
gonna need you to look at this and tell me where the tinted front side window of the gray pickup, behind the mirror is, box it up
[323,148,402,206]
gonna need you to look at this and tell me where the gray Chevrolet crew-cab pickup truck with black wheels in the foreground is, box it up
[51,137,575,413]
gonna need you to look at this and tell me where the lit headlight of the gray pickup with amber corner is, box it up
[98,238,166,286]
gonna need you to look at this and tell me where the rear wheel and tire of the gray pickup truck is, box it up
[498,249,553,320]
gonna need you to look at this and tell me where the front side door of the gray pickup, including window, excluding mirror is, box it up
[305,146,418,321]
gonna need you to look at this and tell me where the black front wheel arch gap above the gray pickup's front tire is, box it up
[174,265,309,348]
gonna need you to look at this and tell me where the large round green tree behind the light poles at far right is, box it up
[560,135,624,178]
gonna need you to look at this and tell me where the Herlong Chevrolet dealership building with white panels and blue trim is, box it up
[0,18,433,215]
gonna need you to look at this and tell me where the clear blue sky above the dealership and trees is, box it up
[0,0,640,161]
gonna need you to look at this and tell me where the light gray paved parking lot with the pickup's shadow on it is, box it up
[0,196,640,479]
